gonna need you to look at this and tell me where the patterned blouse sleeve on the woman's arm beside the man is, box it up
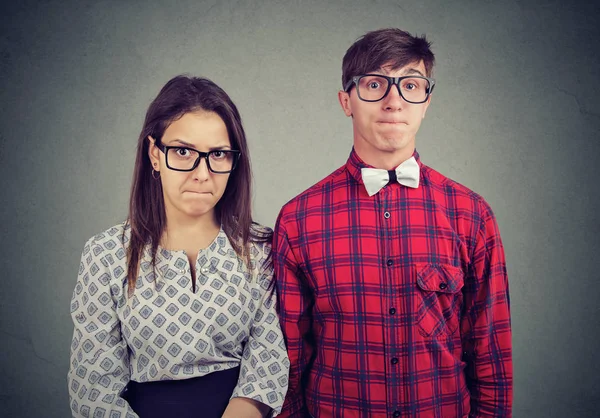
[231,246,290,416]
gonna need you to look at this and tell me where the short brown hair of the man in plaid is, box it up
[342,28,435,88]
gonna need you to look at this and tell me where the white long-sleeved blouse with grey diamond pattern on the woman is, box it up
[68,223,289,418]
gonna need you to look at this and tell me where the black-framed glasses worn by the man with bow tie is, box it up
[344,74,435,104]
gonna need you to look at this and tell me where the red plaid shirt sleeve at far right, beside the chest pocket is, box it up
[461,202,513,418]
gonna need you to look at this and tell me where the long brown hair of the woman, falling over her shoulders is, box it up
[127,75,271,296]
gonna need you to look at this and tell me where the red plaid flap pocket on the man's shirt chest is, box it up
[415,263,464,337]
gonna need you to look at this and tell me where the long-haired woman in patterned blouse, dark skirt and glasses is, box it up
[68,76,289,418]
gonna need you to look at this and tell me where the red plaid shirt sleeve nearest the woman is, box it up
[273,215,312,418]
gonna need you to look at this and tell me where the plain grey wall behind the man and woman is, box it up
[0,0,600,418]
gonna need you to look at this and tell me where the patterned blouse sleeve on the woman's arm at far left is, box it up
[67,239,138,418]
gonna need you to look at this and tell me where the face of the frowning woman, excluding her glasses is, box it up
[148,111,231,222]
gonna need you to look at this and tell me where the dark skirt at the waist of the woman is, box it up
[122,367,240,418]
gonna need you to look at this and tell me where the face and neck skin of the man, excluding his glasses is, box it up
[338,61,431,169]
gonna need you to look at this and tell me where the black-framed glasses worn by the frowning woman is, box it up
[156,144,242,174]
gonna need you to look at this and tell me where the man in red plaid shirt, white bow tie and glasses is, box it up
[274,29,512,418]
